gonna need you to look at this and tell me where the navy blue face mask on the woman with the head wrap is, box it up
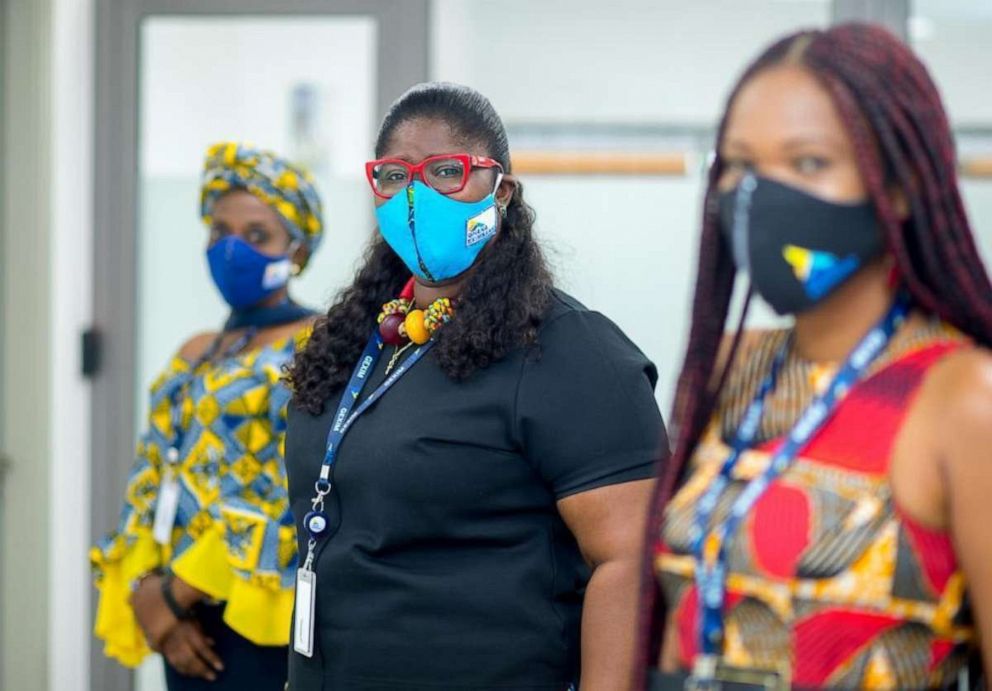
[207,235,292,309]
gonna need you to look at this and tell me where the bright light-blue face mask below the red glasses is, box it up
[375,182,502,283]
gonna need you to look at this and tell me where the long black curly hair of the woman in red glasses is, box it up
[287,82,553,415]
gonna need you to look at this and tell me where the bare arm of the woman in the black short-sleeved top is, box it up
[558,480,654,691]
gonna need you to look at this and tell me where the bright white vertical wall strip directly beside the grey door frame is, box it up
[44,0,94,691]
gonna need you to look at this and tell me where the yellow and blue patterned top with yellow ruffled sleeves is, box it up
[90,329,309,666]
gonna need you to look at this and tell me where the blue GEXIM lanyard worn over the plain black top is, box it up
[303,329,434,570]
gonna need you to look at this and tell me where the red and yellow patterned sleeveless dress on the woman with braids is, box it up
[655,322,976,689]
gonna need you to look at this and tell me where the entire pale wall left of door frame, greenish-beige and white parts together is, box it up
[0,0,93,691]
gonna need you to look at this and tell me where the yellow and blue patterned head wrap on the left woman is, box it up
[200,142,324,254]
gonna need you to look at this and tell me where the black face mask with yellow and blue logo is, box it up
[720,173,884,314]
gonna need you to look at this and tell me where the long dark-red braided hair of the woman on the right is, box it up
[638,23,992,674]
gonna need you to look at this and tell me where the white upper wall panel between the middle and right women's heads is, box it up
[432,0,830,124]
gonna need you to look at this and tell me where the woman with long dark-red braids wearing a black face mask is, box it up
[640,25,992,689]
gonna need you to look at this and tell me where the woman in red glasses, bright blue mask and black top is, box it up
[286,83,667,691]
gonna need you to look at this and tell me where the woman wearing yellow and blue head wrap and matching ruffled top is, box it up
[92,142,323,691]
